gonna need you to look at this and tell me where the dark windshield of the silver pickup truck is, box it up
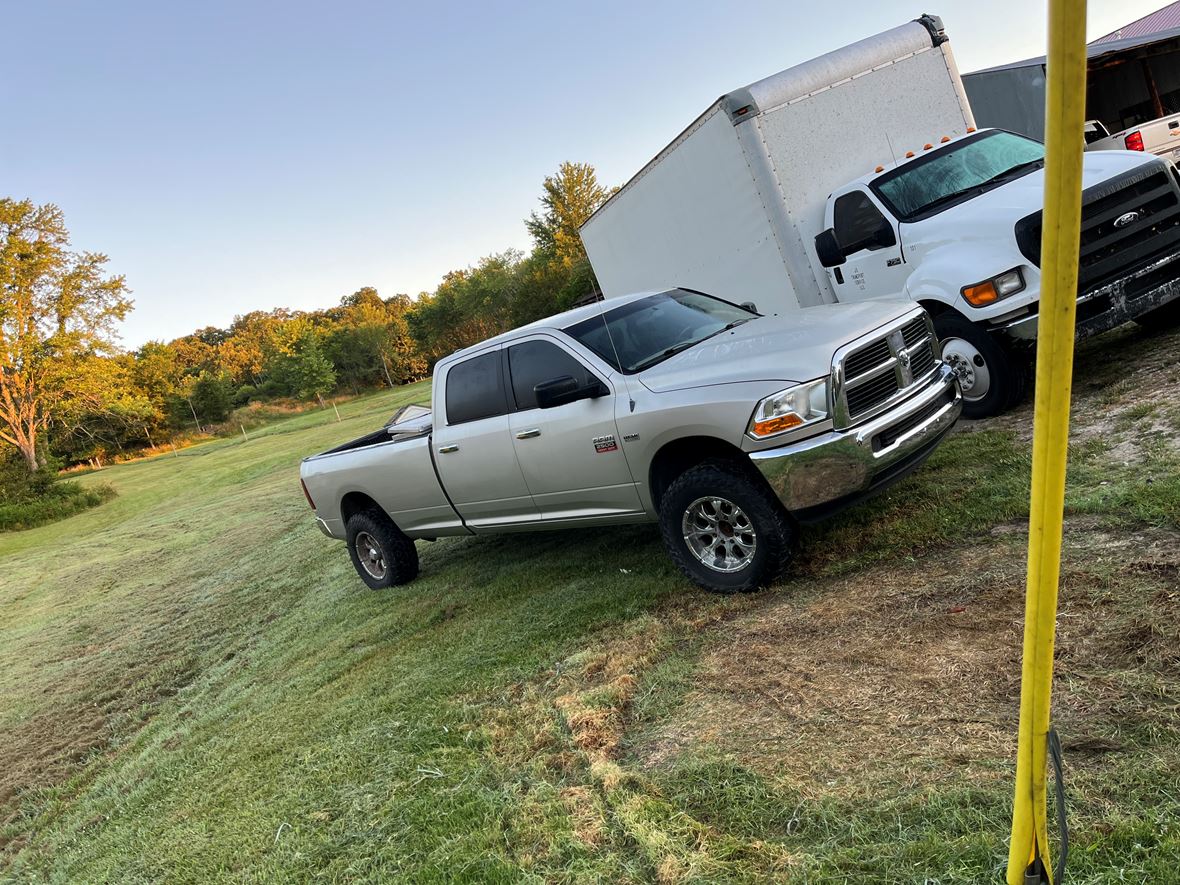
[565,289,758,375]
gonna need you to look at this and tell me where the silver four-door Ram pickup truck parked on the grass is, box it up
[301,289,962,592]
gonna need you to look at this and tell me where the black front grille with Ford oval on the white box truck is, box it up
[1016,164,1180,294]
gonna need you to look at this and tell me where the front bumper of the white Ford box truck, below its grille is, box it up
[996,253,1180,341]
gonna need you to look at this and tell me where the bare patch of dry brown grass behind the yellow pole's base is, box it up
[640,520,1180,795]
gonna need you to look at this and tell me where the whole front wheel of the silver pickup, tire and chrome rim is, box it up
[660,461,794,594]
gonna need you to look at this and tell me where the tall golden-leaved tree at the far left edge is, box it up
[0,198,131,471]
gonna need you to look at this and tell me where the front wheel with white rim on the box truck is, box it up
[935,310,1027,418]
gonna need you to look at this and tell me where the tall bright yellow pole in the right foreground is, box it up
[1008,0,1086,885]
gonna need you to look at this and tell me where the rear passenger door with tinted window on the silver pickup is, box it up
[433,347,539,529]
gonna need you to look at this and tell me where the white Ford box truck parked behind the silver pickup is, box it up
[581,15,1180,417]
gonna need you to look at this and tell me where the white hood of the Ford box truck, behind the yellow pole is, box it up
[902,151,1161,260]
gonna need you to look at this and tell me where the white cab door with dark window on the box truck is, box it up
[827,190,910,301]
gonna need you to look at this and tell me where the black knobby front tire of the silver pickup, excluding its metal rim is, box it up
[660,460,795,594]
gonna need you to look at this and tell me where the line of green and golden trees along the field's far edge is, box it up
[0,163,610,474]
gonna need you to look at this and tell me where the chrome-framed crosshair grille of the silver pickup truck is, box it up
[833,312,938,426]
